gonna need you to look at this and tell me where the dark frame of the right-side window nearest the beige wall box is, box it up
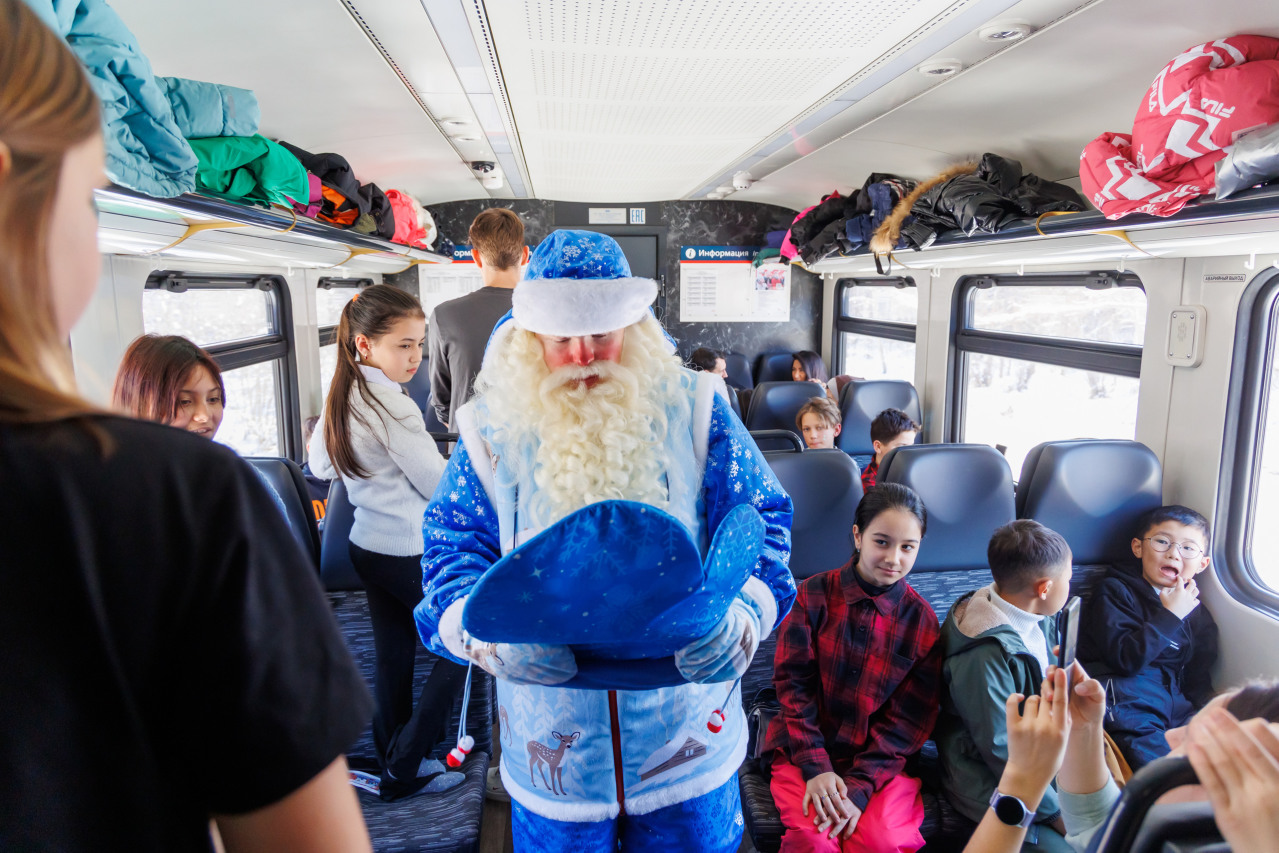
[944,272,1149,445]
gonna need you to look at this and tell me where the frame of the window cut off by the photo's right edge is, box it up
[1212,267,1279,619]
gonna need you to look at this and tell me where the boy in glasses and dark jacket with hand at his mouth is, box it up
[1079,506,1216,770]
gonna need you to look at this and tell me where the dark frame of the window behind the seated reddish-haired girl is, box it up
[143,270,302,460]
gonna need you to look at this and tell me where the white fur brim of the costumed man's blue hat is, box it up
[510,278,657,338]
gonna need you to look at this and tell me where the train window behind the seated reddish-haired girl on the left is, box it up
[142,271,301,457]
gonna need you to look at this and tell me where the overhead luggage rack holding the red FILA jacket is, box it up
[808,184,1279,275]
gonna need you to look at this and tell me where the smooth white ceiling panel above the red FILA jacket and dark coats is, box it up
[732,0,1279,208]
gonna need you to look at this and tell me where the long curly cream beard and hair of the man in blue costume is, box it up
[475,316,684,526]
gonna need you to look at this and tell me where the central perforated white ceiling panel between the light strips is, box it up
[485,0,978,201]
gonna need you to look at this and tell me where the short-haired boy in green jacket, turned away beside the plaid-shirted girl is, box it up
[934,519,1072,853]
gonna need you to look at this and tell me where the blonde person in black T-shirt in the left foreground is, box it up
[0,0,371,852]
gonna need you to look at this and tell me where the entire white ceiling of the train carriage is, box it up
[110,0,1279,208]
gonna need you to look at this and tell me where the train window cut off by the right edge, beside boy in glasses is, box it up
[1214,264,1279,606]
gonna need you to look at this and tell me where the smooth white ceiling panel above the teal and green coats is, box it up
[104,0,487,203]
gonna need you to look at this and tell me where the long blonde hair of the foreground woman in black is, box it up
[0,0,100,423]
